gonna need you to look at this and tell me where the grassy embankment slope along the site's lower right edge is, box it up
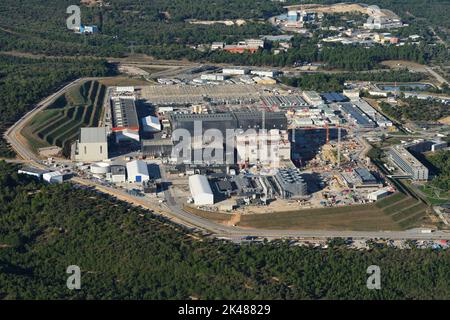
[188,193,427,231]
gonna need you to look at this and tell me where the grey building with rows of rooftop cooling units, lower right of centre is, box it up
[274,168,308,199]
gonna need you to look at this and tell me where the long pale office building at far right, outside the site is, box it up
[388,145,429,180]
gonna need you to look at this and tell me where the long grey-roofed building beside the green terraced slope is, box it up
[111,96,140,142]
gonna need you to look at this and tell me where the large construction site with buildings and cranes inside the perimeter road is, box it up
[14,63,442,230]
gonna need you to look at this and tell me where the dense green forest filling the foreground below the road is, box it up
[0,162,450,299]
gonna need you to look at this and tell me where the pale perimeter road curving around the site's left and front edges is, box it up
[5,78,450,241]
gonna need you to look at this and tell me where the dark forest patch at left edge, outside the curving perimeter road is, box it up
[0,54,115,157]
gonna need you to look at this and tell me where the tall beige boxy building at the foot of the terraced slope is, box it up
[72,127,108,162]
